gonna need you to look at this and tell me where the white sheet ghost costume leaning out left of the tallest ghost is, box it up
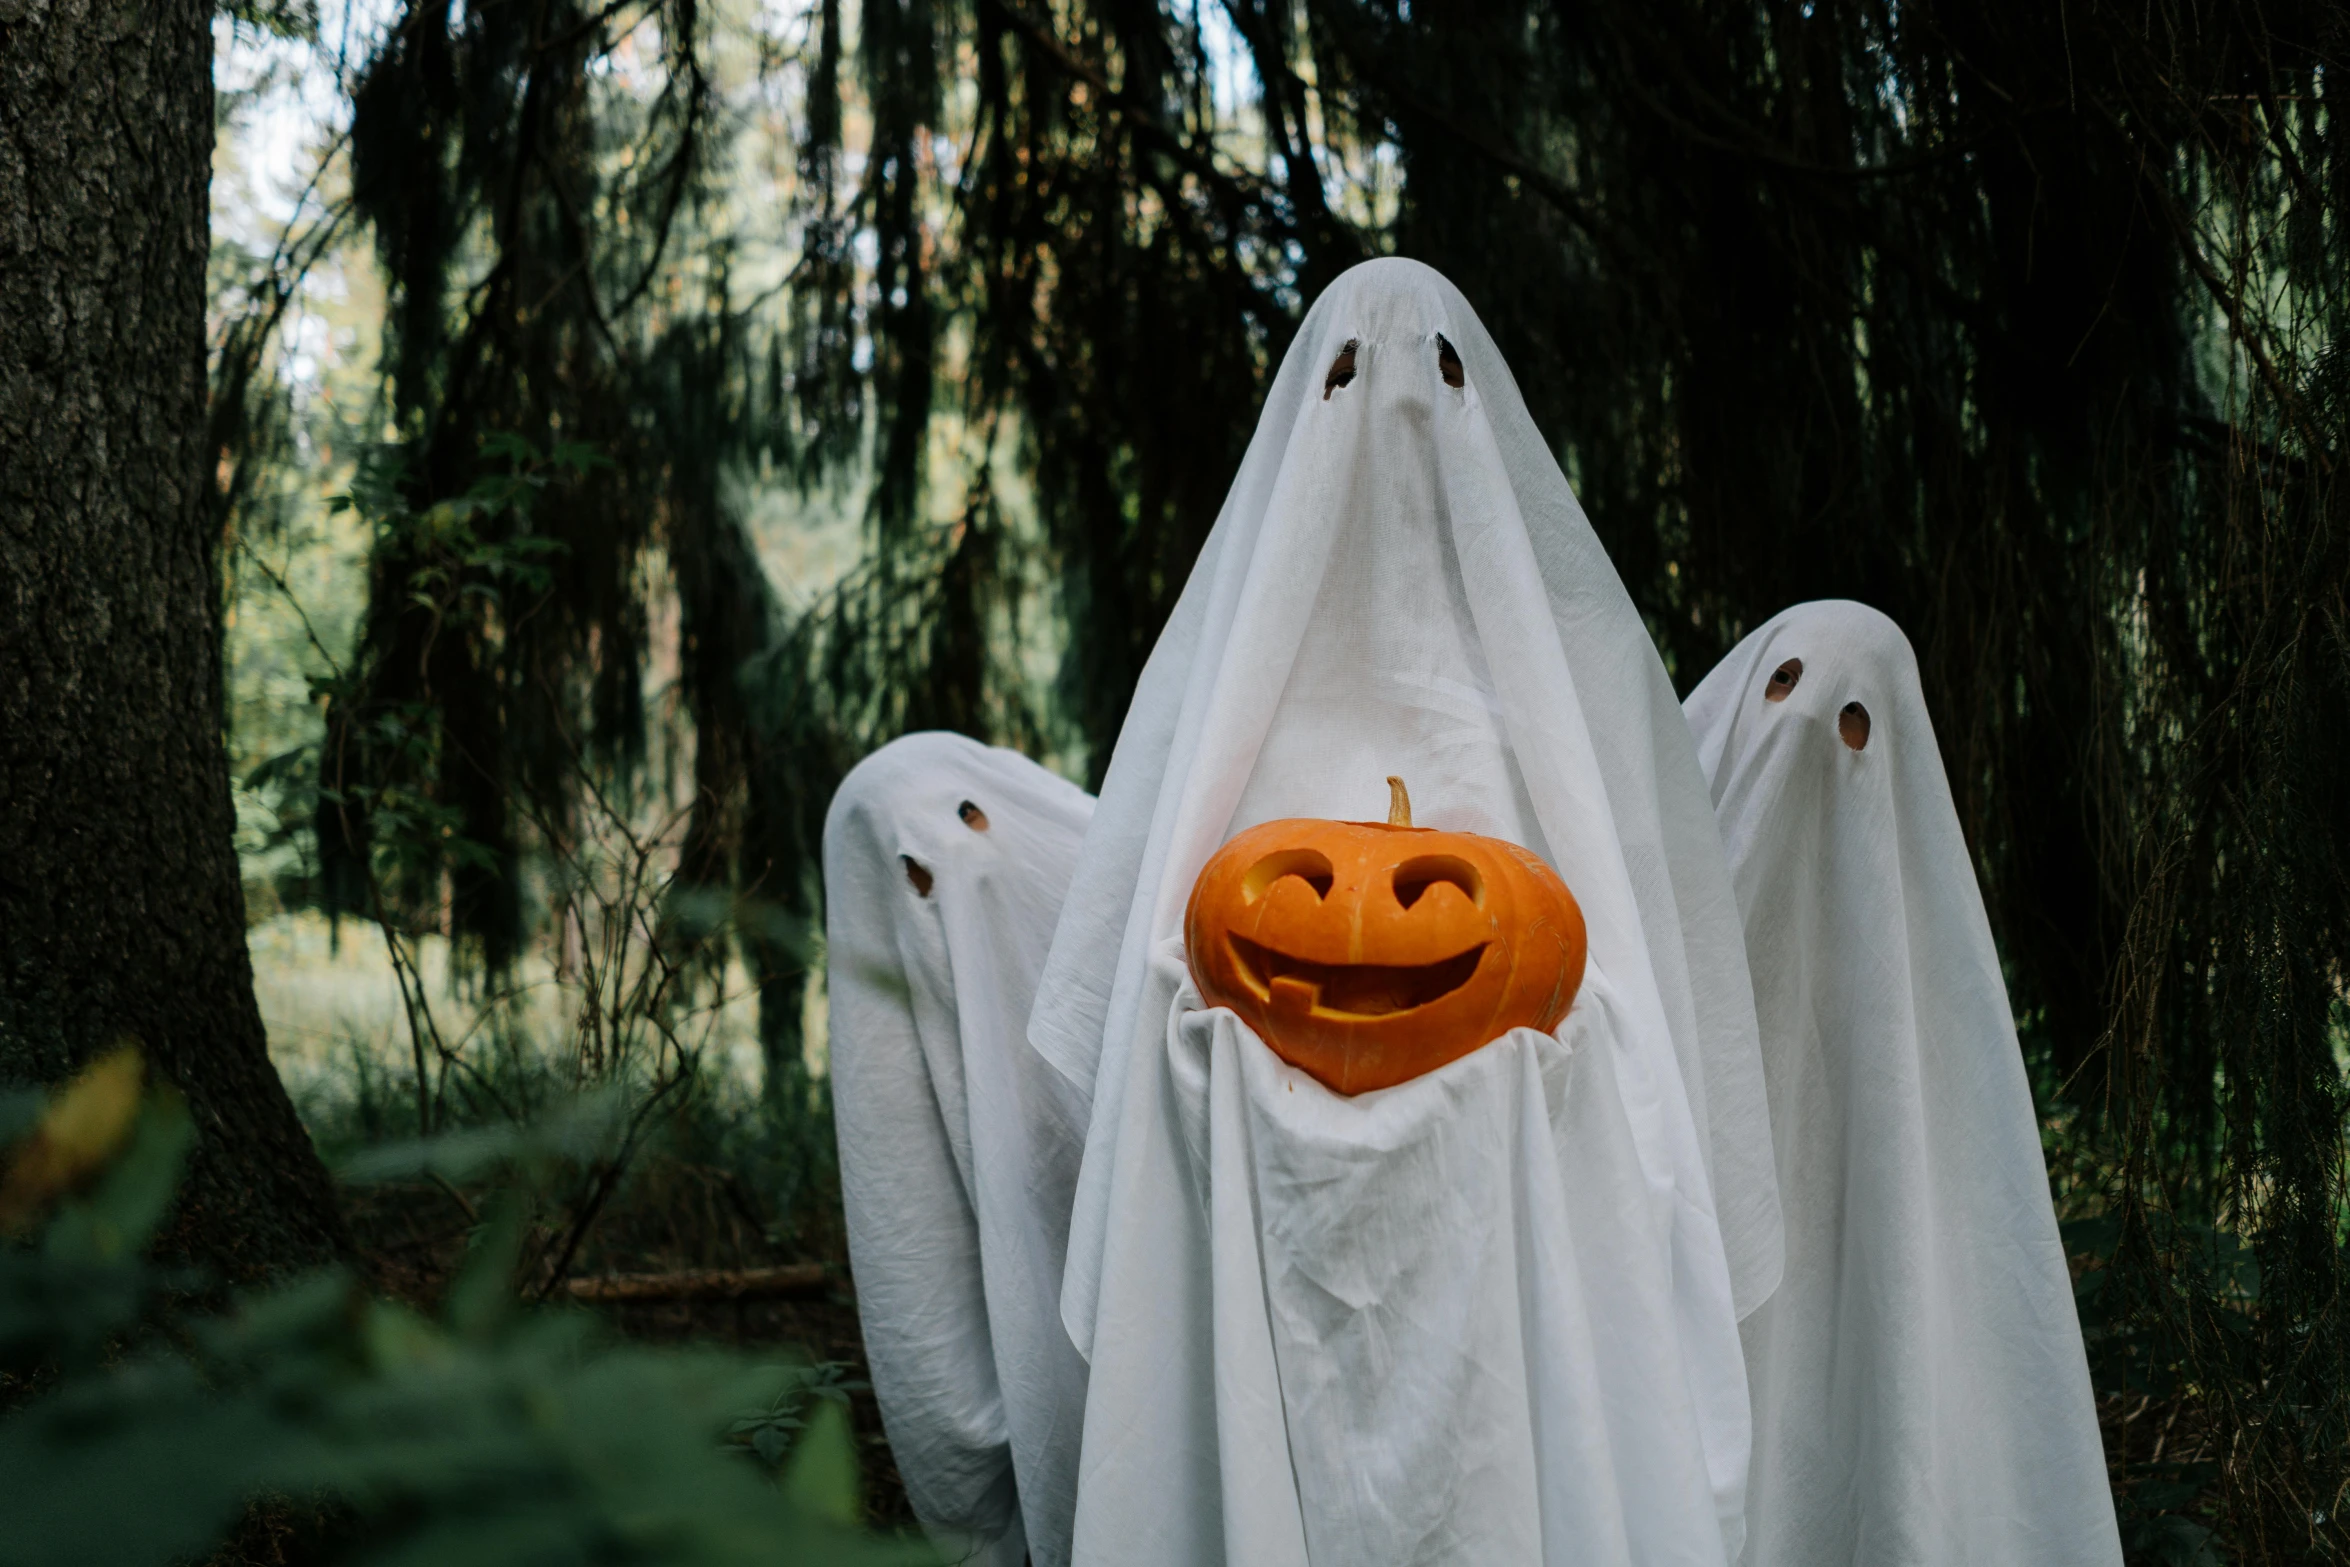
[825,733,1093,1567]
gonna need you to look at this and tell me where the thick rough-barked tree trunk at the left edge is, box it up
[0,0,343,1278]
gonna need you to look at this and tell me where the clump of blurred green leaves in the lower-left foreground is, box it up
[0,1078,938,1567]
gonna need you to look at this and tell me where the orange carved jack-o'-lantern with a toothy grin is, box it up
[1184,778,1584,1095]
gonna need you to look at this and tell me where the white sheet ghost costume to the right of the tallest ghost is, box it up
[1687,601,2122,1567]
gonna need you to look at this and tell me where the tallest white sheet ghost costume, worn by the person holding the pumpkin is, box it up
[1029,261,1779,1567]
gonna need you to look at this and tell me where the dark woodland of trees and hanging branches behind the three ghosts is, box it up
[0,0,2350,1562]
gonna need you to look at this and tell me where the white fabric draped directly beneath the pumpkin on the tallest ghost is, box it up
[1076,944,1734,1567]
